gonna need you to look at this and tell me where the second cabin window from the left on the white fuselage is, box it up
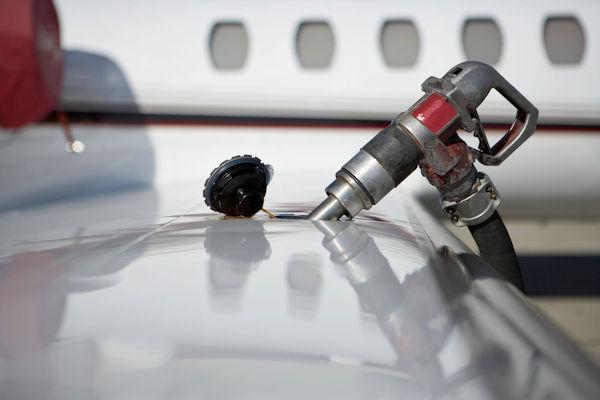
[296,21,335,69]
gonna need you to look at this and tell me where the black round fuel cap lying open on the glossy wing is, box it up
[204,155,273,217]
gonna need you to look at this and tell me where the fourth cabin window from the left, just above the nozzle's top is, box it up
[463,18,502,65]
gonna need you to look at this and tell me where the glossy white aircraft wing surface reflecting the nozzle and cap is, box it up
[0,186,599,399]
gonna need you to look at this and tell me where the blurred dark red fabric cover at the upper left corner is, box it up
[0,0,62,128]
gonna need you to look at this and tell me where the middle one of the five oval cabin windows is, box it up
[380,20,419,68]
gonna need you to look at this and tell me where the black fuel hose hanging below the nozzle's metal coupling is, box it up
[469,211,523,291]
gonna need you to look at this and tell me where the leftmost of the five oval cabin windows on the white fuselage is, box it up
[210,22,248,69]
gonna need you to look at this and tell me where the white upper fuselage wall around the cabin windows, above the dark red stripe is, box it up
[56,0,600,124]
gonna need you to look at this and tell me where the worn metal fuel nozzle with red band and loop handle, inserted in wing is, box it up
[307,61,538,224]
